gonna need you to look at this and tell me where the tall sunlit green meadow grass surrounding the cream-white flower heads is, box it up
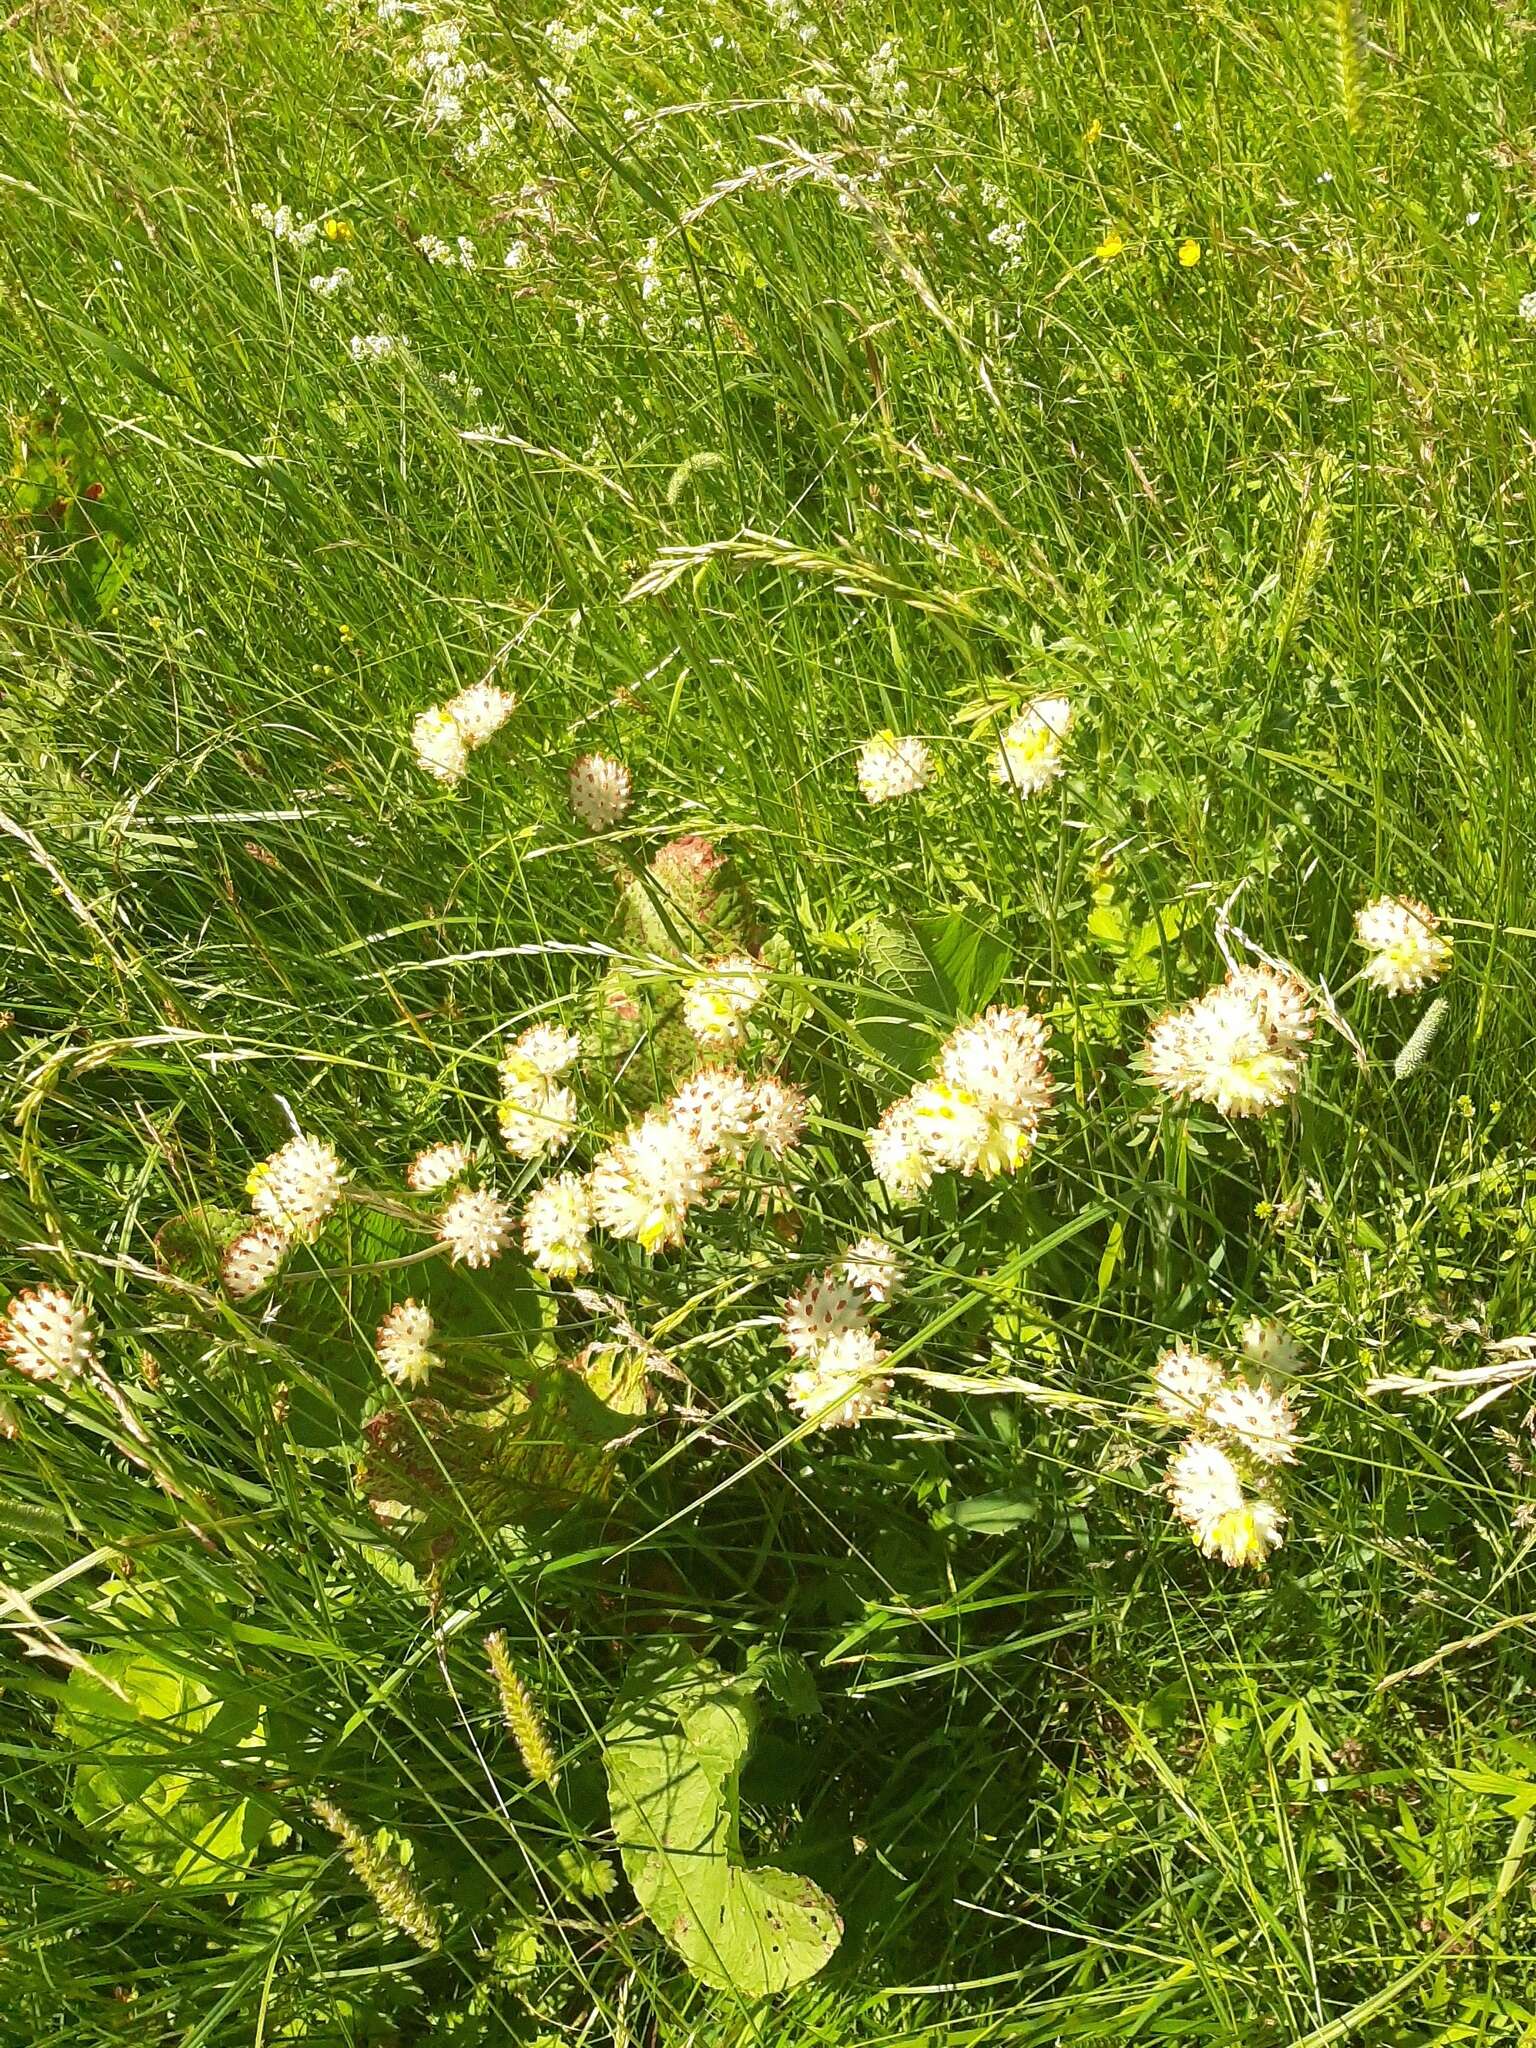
[0,0,1536,2048]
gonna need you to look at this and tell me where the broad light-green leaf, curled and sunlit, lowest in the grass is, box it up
[602,1663,842,1997]
